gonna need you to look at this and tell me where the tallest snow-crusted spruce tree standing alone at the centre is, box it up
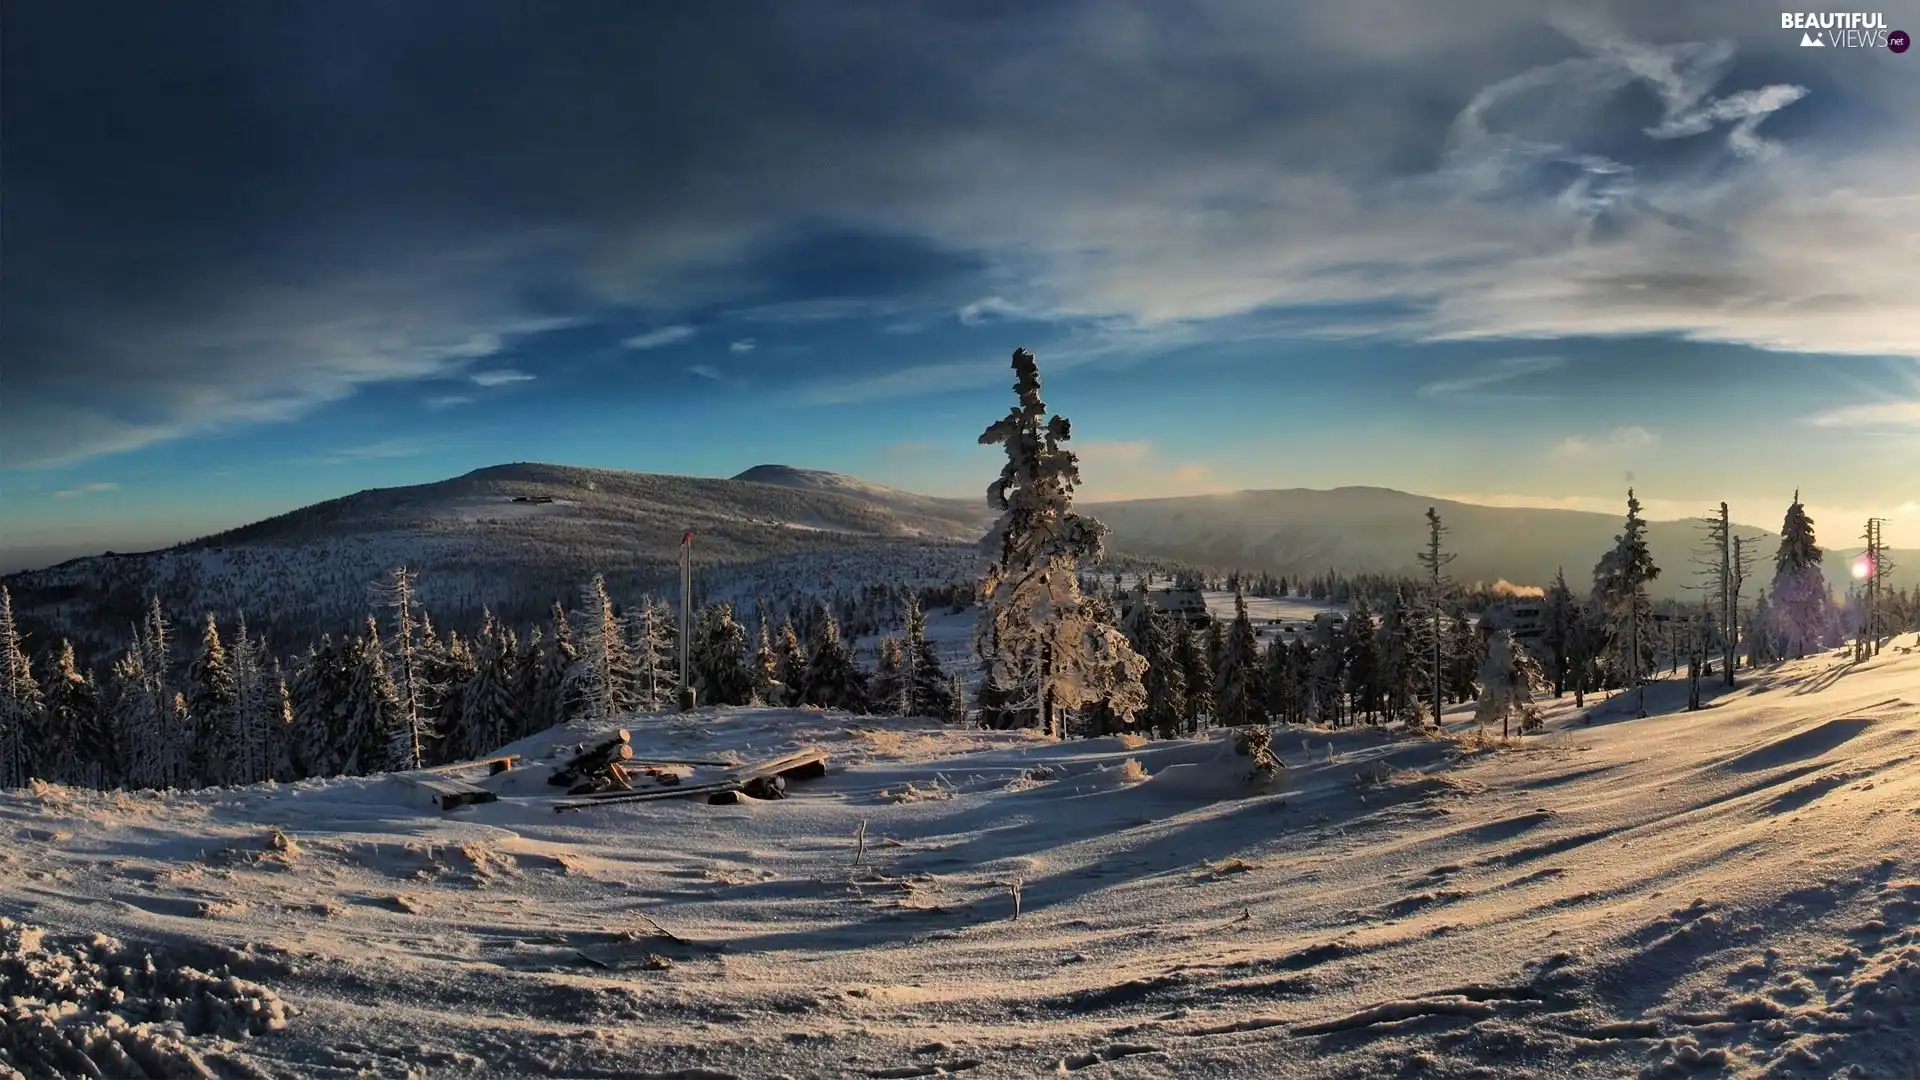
[973,350,1146,738]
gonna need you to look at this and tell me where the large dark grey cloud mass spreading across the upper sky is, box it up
[0,0,1920,467]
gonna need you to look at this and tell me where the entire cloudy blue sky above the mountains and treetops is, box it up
[0,0,1920,569]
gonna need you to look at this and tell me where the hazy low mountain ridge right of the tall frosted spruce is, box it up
[1087,488,1920,596]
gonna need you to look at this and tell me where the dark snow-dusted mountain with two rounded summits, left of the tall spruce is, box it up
[4,463,989,661]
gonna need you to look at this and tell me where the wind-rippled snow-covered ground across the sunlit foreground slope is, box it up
[0,636,1920,1080]
